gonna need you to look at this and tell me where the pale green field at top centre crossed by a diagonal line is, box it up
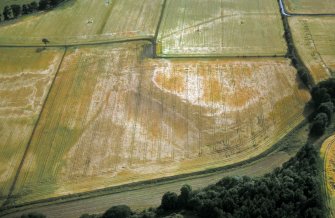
[157,0,287,56]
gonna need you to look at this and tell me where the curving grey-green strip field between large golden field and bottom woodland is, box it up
[5,121,308,218]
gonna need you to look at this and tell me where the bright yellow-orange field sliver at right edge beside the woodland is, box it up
[320,135,335,214]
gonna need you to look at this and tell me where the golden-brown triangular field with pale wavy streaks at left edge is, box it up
[0,48,63,204]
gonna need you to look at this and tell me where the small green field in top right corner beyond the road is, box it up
[284,0,335,14]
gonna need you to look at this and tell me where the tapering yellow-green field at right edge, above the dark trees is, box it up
[289,17,335,82]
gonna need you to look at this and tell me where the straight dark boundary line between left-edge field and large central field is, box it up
[0,48,67,210]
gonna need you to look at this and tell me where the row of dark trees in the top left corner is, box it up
[0,0,65,22]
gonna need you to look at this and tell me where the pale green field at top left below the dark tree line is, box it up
[0,0,162,45]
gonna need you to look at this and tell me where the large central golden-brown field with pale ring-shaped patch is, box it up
[14,42,310,203]
